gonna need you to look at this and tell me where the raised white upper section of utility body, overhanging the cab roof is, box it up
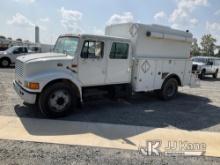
[105,23,192,59]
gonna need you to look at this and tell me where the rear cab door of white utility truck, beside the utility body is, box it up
[106,42,131,84]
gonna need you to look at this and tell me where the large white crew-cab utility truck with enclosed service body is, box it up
[13,23,197,117]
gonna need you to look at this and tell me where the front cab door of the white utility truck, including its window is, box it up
[78,39,106,86]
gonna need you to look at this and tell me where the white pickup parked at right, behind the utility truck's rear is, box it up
[192,56,220,79]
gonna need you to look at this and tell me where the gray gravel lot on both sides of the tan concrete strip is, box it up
[0,69,220,164]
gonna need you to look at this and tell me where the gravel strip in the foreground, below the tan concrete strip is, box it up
[0,140,220,165]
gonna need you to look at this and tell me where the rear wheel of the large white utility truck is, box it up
[159,78,178,100]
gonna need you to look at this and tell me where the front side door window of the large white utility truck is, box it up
[81,40,104,58]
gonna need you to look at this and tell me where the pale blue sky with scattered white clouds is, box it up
[0,0,220,44]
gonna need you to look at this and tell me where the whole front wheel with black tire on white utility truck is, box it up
[38,83,77,118]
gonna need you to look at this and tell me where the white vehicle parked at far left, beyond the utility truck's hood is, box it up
[0,46,28,67]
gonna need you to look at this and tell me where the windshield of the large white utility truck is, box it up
[54,37,79,56]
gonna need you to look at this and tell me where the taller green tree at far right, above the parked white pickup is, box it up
[201,34,216,56]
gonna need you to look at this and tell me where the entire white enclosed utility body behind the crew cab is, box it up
[105,23,197,92]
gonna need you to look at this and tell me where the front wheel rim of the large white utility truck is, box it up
[49,90,71,112]
